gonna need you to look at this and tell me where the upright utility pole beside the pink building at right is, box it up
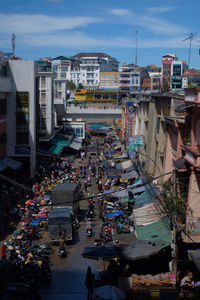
[172,169,178,278]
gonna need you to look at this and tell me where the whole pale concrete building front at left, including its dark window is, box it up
[7,60,37,177]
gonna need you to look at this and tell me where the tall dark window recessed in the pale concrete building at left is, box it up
[16,92,29,145]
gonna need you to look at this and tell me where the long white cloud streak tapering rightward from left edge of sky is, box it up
[0,14,102,34]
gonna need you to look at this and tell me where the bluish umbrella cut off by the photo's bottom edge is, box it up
[94,285,126,300]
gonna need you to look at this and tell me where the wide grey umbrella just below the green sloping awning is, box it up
[120,240,164,261]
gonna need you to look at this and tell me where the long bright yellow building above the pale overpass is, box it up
[75,89,118,103]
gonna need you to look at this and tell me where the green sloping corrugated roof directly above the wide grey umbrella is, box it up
[136,217,171,245]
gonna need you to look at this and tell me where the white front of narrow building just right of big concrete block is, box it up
[38,72,54,134]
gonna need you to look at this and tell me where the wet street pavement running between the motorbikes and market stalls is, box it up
[39,142,102,300]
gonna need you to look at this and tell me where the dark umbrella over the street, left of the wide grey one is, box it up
[82,244,119,259]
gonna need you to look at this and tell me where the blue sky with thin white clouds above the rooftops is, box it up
[0,0,200,69]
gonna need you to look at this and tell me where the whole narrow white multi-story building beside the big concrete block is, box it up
[37,61,54,137]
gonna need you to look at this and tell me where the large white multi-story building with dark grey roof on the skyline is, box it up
[72,52,119,89]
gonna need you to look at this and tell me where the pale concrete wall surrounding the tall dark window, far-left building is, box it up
[7,60,37,176]
